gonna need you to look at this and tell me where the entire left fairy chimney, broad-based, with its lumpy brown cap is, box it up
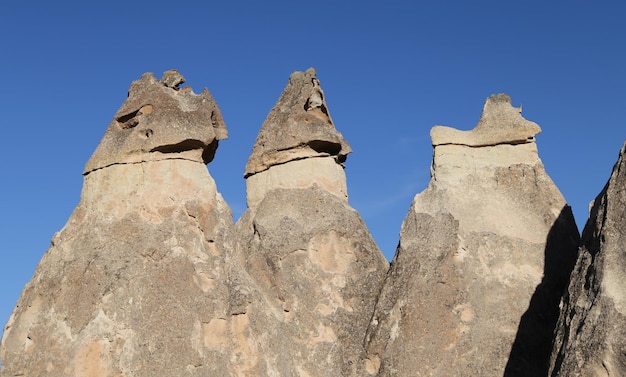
[0,71,266,376]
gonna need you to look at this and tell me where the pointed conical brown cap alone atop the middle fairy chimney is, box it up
[244,68,352,178]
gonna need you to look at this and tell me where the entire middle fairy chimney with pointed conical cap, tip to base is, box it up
[236,69,388,376]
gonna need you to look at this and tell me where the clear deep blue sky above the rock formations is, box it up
[0,0,626,338]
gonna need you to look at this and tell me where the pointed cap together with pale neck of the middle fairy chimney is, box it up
[244,68,352,207]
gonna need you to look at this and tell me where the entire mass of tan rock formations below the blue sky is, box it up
[0,69,626,377]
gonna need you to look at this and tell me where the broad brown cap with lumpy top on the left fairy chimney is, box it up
[83,70,228,174]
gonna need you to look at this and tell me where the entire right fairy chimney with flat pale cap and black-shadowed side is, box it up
[366,94,579,376]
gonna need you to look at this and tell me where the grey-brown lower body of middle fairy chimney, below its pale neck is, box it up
[236,187,389,377]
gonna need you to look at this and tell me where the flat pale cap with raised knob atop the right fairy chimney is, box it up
[430,94,541,147]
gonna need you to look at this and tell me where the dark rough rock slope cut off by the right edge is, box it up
[550,140,626,377]
